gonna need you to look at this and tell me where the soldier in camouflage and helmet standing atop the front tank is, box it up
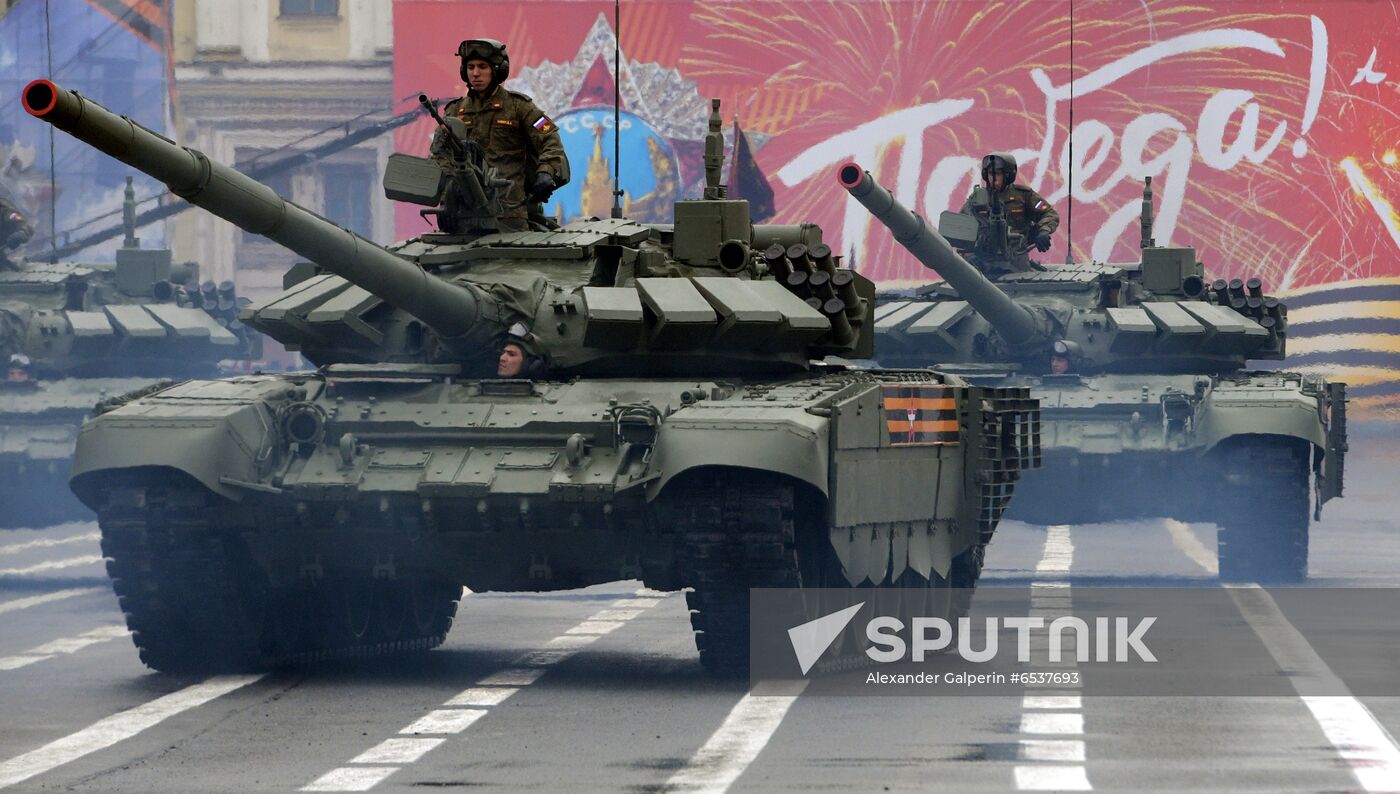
[433,39,570,231]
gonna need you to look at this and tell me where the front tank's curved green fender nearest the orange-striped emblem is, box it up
[647,415,829,501]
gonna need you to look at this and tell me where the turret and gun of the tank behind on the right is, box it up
[839,164,1287,372]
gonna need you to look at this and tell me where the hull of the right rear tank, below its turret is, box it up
[974,371,1345,581]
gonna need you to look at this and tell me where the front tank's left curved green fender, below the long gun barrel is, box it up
[69,402,276,508]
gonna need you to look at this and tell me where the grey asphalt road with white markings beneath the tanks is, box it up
[0,437,1400,793]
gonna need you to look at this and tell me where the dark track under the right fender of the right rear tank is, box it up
[1217,438,1310,584]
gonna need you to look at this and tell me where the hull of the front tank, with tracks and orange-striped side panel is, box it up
[73,367,1035,669]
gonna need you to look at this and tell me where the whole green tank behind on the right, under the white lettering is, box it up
[840,164,1347,583]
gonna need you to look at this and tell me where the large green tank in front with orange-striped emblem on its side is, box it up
[24,81,1037,674]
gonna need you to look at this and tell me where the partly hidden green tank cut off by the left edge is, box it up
[0,181,260,528]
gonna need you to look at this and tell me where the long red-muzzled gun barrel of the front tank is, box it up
[22,80,482,340]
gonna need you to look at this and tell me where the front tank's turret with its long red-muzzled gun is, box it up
[24,80,874,374]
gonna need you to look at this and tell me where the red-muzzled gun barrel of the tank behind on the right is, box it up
[837,162,1042,344]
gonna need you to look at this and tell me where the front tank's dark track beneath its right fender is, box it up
[671,472,801,675]
